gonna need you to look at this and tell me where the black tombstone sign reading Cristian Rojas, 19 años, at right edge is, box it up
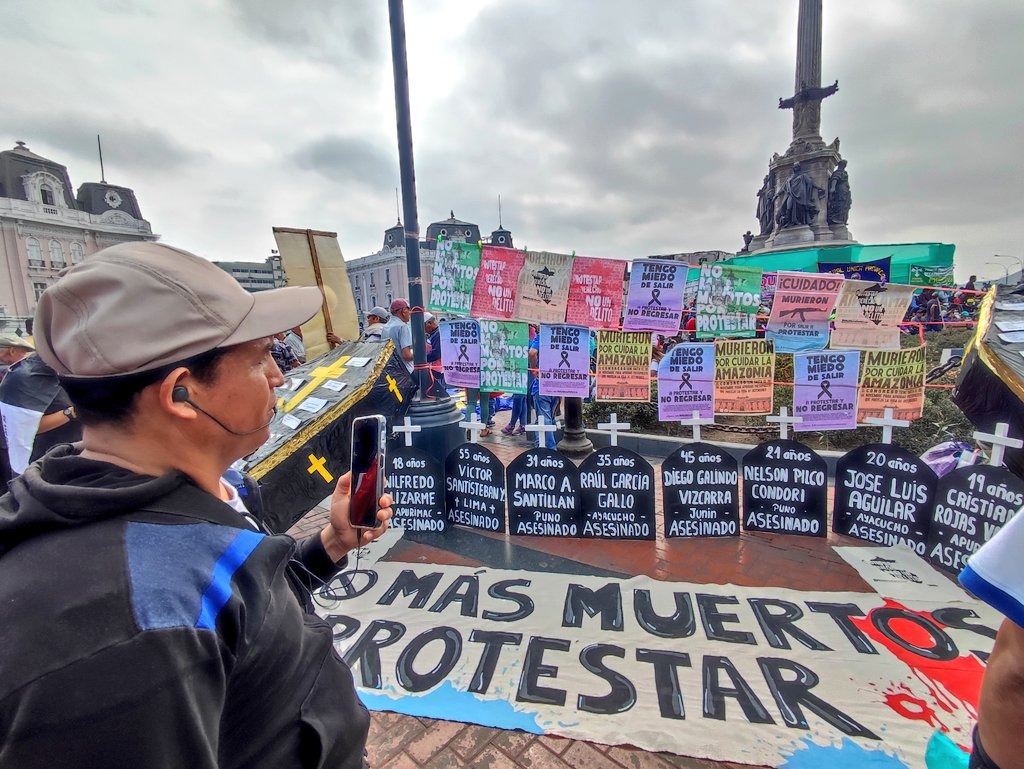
[926,465,1024,572]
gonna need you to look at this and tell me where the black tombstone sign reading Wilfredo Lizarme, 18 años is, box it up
[386,446,447,531]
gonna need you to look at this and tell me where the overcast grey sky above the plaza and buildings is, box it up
[0,0,1024,280]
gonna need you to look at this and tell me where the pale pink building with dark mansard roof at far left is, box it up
[0,141,159,330]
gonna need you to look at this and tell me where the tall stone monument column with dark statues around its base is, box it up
[742,0,855,253]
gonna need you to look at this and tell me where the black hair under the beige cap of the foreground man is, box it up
[60,346,234,425]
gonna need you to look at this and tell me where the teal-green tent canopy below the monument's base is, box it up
[721,243,956,284]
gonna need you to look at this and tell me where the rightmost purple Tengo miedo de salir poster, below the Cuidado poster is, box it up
[793,350,860,432]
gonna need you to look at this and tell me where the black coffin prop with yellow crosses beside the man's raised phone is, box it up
[242,342,416,531]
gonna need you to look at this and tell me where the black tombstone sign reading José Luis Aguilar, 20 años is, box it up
[833,443,936,556]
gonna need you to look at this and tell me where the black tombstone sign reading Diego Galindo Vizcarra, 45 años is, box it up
[662,443,739,538]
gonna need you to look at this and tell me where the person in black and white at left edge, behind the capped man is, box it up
[0,337,82,475]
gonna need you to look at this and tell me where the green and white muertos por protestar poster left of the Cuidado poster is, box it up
[696,264,762,339]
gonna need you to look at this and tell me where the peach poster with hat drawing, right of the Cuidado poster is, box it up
[828,280,913,350]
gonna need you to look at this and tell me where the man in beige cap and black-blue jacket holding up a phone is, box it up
[0,243,391,769]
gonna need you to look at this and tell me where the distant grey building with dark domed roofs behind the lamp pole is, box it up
[345,211,515,323]
